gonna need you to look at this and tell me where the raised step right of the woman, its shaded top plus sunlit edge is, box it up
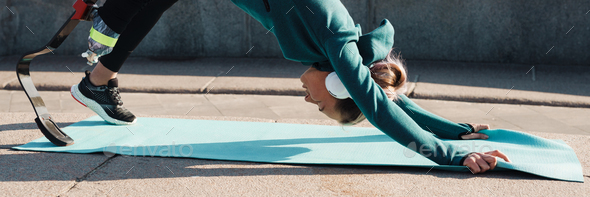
[407,61,590,107]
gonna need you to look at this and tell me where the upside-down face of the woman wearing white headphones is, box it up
[300,67,341,121]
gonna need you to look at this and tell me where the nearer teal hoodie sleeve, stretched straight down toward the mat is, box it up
[325,36,468,165]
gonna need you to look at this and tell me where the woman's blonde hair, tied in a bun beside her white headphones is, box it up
[336,49,408,125]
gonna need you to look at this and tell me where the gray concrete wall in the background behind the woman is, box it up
[0,0,590,65]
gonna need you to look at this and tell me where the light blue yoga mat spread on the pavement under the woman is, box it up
[14,116,584,182]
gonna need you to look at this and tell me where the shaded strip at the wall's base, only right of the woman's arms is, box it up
[407,61,590,96]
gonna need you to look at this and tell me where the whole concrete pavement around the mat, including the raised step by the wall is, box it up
[0,56,590,196]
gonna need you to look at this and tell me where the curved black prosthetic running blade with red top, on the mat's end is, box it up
[16,0,97,146]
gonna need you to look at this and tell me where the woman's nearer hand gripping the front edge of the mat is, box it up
[463,150,510,174]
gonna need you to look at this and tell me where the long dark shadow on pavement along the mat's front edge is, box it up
[0,149,550,181]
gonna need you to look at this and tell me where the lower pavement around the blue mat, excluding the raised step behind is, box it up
[0,91,590,196]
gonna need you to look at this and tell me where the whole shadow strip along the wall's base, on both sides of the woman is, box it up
[0,56,590,96]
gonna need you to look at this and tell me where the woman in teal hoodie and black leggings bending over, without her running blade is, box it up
[81,0,509,173]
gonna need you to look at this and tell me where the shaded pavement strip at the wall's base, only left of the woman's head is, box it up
[0,55,308,78]
